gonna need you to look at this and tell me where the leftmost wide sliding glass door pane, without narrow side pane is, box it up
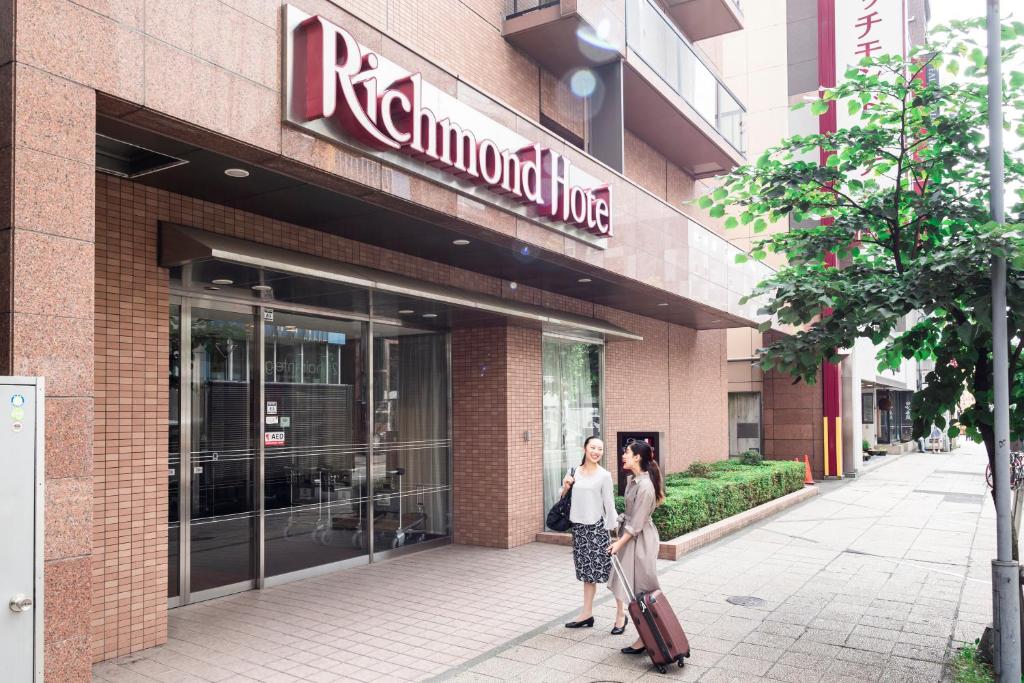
[187,306,257,597]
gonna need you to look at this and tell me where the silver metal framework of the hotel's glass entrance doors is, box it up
[168,283,454,608]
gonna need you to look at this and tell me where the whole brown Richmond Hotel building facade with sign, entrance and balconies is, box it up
[0,0,799,681]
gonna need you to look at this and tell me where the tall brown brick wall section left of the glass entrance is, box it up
[92,176,168,659]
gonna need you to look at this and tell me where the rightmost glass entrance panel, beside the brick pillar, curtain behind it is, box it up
[373,324,452,552]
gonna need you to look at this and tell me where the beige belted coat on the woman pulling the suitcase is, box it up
[608,472,662,602]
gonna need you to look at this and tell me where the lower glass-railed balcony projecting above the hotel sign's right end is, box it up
[504,0,745,177]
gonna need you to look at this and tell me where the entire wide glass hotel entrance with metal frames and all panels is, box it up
[168,290,452,607]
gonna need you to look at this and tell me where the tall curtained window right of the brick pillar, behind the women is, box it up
[543,336,603,528]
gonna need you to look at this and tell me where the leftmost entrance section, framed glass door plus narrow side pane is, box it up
[168,302,257,601]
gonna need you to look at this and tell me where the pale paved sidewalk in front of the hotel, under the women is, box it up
[93,446,994,681]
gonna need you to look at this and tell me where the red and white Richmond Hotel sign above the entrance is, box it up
[285,5,612,242]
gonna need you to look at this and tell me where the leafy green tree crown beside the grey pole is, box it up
[698,19,1024,497]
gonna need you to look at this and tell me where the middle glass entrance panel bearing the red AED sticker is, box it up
[263,311,370,577]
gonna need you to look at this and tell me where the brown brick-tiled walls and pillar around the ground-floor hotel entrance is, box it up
[91,174,726,659]
